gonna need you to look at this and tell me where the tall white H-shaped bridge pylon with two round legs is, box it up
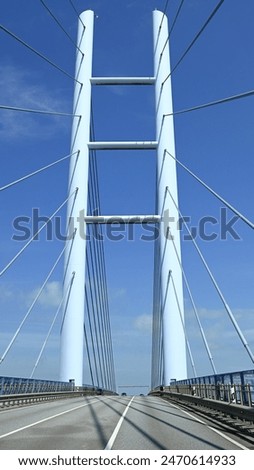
[60,10,187,385]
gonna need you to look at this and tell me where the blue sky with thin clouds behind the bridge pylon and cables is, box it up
[0,0,254,392]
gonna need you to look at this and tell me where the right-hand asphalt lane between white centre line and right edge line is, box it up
[108,397,248,450]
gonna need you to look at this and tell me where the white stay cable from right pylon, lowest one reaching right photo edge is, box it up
[167,187,254,363]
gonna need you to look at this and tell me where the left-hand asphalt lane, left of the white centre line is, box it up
[0,397,128,450]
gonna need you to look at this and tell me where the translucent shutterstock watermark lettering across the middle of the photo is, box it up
[12,207,241,242]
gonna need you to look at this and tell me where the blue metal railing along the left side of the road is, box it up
[0,377,74,395]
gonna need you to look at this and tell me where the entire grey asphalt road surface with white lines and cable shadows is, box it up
[0,396,253,450]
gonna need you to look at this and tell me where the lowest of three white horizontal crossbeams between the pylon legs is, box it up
[84,215,161,224]
